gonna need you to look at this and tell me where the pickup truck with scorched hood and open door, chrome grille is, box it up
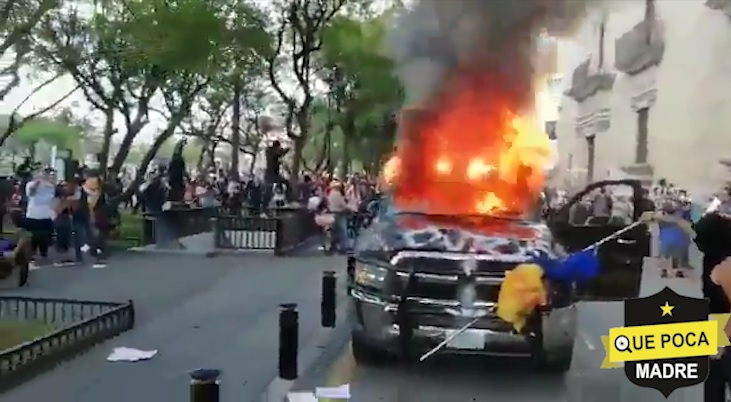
[348,180,650,372]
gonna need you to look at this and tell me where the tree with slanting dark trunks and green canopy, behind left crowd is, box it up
[34,0,229,181]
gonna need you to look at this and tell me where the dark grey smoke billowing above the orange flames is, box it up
[387,0,601,112]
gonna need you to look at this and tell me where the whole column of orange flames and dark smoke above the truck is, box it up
[386,0,602,215]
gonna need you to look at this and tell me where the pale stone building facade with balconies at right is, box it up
[556,0,731,191]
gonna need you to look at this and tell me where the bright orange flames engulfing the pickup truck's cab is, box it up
[383,72,552,215]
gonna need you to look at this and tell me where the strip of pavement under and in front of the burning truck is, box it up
[294,258,702,402]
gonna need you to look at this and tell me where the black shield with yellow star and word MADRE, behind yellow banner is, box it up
[624,287,710,398]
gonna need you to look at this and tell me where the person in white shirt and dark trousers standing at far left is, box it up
[23,170,56,260]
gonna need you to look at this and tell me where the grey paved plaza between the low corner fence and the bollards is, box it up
[2,253,344,402]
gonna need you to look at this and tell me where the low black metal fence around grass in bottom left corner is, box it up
[0,296,135,389]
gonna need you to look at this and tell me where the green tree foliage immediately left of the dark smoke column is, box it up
[320,13,403,174]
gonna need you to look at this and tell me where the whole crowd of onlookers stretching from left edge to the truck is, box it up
[0,151,384,266]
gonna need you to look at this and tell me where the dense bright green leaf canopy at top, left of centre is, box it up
[92,0,271,75]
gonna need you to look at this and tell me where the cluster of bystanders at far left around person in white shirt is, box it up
[0,160,119,266]
